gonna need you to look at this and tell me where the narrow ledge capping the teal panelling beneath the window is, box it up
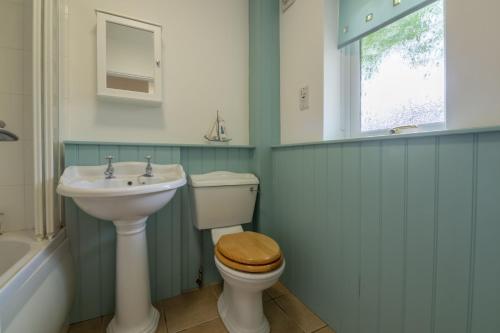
[271,126,500,149]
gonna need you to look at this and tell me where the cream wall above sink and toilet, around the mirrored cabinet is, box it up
[62,0,249,144]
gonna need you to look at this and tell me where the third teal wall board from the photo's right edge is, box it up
[403,137,437,333]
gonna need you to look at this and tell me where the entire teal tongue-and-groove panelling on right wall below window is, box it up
[272,132,500,333]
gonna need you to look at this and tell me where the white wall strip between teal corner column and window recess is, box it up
[280,0,324,143]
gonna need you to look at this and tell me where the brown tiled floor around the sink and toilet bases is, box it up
[69,283,333,333]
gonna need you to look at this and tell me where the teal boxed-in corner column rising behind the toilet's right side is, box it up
[248,0,280,232]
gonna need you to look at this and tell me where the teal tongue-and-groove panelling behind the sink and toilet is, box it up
[65,143,253,322]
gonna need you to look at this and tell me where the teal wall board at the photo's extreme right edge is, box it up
[469,133,500,332]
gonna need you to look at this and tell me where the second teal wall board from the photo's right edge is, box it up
[435,135,475,333]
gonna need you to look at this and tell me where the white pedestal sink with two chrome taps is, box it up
[57,162,186,333]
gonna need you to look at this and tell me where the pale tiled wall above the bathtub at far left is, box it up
[0,0,34,231]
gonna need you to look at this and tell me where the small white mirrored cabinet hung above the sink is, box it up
[97,11,162,104]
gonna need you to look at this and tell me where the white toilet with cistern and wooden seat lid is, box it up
[189,171,285,333]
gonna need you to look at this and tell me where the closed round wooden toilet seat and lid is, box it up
[215,231,283,273]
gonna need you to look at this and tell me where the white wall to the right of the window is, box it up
[446,0,500,129]
